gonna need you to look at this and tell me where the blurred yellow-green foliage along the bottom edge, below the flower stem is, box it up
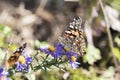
[38,67,115,80]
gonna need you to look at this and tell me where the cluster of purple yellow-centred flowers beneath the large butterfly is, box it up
[40,43,80,69]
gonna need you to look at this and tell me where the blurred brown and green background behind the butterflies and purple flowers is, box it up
[0,0,120,80]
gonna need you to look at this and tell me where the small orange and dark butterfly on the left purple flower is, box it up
[7,43,26,67]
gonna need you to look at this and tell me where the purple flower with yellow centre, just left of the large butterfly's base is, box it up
[40,43,64,59]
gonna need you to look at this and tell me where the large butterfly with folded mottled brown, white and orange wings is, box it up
[58,17,86,55]
